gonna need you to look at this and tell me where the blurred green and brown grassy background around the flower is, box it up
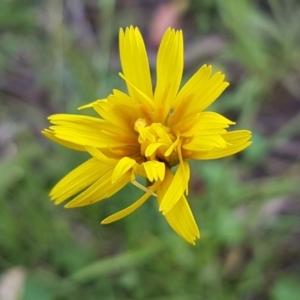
[0,0,300,300]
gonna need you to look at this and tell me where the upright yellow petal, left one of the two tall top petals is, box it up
[119,26,153,102]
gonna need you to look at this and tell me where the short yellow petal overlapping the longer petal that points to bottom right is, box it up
[159,161,190,214]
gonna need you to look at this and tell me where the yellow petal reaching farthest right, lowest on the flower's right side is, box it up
[188,130,252,160]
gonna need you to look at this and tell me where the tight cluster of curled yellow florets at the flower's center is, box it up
[134,118,181,167]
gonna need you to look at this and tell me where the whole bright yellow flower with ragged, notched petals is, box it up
[43,27,251,244]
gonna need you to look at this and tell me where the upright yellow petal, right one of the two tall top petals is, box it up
[154,28,183,123]
